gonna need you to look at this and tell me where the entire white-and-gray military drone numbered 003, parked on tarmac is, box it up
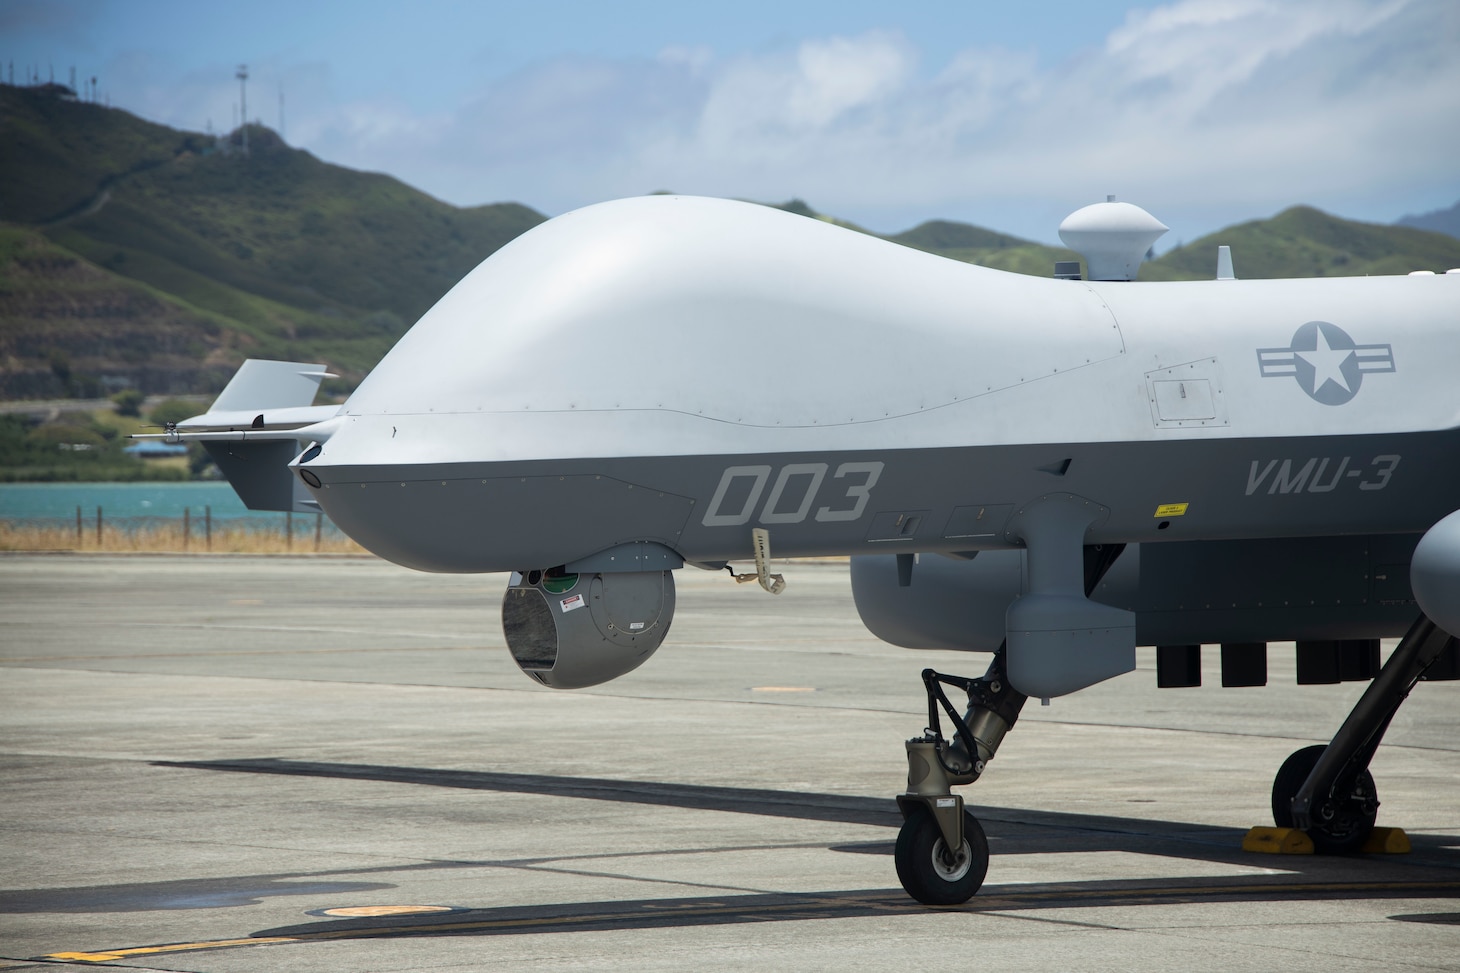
[145,196,1460,904]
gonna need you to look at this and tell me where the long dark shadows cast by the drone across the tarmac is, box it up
[139,758,1460,935]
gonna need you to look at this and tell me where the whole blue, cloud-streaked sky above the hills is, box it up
[0,0,1460,243]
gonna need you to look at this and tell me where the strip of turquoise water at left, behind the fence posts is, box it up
[0,481,283,522]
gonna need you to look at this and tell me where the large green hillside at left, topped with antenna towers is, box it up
[0,85,545,397]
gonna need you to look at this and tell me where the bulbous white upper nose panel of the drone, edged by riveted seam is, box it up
[347,196,1121,428]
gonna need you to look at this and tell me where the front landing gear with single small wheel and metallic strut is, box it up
[895,647,1026,906]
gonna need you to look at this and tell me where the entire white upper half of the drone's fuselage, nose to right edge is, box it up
[320,196,1460,465]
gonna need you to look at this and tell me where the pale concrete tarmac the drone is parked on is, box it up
[0,555,1460,973]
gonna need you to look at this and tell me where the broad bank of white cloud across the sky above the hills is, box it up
[110,0,1460,241]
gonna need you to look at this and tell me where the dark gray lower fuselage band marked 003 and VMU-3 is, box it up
[310,430,1460,571]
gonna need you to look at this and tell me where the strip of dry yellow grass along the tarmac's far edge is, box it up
[0,517,366,554]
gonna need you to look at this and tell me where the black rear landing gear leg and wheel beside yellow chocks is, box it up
[1273,615,1456,855]
